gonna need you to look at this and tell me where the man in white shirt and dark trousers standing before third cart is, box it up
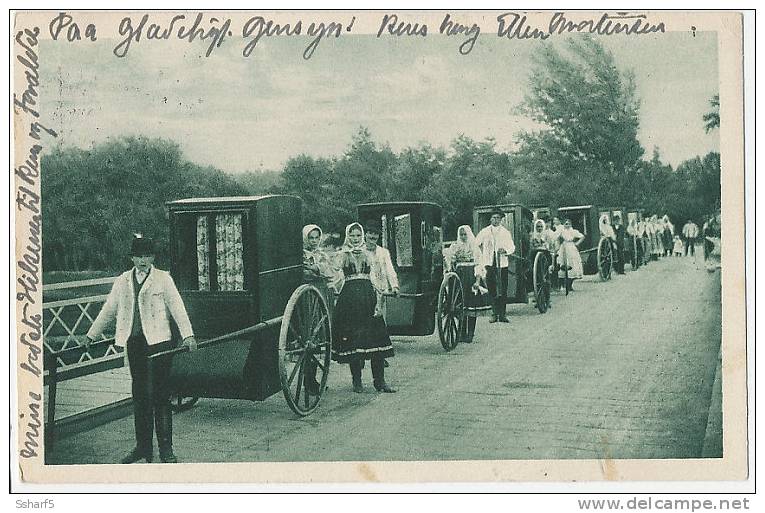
[475,209,515,322]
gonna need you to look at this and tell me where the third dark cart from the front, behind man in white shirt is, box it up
[473,203,552,313]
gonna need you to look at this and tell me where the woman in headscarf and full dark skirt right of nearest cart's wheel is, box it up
[332,223,395,393]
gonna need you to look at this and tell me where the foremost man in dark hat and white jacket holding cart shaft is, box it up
[85,235,196,463]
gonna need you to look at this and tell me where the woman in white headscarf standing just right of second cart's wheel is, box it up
[444,224,489,344]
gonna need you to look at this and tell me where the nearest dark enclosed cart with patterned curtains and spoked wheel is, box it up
[167,196,330,414]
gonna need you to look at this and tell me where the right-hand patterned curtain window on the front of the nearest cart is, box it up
[215,214,244,291]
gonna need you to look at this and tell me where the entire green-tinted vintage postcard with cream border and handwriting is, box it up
[10,9,753,484]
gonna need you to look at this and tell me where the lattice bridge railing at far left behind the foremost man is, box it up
[43,277,124,447]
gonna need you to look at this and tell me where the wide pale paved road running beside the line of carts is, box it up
[49,258,722,464]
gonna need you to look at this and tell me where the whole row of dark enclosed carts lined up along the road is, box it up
[155,195,645,416]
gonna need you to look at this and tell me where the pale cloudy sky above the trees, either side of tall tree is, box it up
[40,32,719,173]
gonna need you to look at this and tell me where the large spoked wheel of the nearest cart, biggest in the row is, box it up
[279,285,332,416]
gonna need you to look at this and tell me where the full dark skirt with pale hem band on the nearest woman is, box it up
[332,280,393,363]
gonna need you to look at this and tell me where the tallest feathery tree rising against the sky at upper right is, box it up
[518,36,644,208]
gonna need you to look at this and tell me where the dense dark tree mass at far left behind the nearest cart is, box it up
[40,137,245,271]
